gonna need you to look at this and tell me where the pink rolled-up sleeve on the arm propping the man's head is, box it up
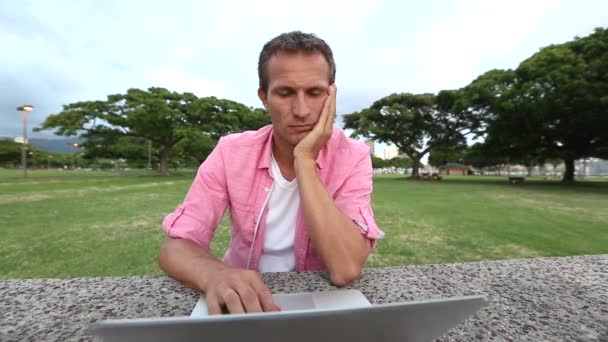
[334,150,384,248]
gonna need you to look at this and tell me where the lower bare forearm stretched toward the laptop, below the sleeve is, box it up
[158,237,228,292]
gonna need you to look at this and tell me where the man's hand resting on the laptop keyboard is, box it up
[203,267,280,315]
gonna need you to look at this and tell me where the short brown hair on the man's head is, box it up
[258,31,336,92]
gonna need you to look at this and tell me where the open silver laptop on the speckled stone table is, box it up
[91,290,487,342]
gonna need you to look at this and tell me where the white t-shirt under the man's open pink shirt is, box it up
[259,154,300,272]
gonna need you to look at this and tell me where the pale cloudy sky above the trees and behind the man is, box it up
[0,0,608,155]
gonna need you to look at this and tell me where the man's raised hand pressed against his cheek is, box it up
[293,83,336,161]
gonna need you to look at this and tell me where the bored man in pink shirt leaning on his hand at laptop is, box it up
[159,32,383,314]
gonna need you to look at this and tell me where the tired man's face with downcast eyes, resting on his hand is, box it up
[258,52,330,148]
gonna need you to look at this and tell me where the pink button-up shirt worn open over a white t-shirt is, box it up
[163,125,384,271]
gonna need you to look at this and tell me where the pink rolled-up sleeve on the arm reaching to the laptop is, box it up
[162,140,228,249]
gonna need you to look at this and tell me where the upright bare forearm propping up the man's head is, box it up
[295,158,371,286]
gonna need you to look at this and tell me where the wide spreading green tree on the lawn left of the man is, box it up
[37,88,270,175]
